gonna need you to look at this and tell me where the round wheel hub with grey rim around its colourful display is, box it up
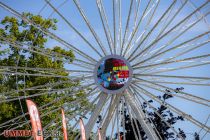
[94,55,132,94]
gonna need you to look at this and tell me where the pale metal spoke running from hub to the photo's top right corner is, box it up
[129,1,208,61]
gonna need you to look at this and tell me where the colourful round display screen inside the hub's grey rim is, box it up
[97,58,129,90]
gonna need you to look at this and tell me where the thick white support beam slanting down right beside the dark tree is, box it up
[124,91,158,139]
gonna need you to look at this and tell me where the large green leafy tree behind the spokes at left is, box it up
[0,13,88,139]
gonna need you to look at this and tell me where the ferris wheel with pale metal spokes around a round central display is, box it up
[0,0,210,140]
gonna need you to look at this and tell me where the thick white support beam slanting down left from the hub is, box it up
[85,93,108,138]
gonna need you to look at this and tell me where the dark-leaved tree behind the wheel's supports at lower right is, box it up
[116,87,199,140]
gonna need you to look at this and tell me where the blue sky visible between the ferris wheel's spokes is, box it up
[0,0,210,140]
